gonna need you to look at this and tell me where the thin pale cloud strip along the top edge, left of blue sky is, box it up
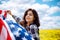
[0,0,35,4]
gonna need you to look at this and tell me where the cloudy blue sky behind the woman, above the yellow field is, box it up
[0,0,60,29]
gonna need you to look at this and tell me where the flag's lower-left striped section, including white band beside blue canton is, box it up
[0,18,15,40]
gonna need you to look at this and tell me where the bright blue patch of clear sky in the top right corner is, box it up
[36,0,60,6]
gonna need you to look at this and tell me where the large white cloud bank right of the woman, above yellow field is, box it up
[40,6,60,29]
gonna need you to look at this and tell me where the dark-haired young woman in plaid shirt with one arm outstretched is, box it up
[7,9,40,40]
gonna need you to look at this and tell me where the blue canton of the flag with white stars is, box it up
[6,20,34,40]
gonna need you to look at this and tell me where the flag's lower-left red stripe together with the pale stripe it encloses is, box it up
[0,19,11,40]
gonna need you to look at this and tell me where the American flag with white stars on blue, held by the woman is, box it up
[0,9,34,40]
